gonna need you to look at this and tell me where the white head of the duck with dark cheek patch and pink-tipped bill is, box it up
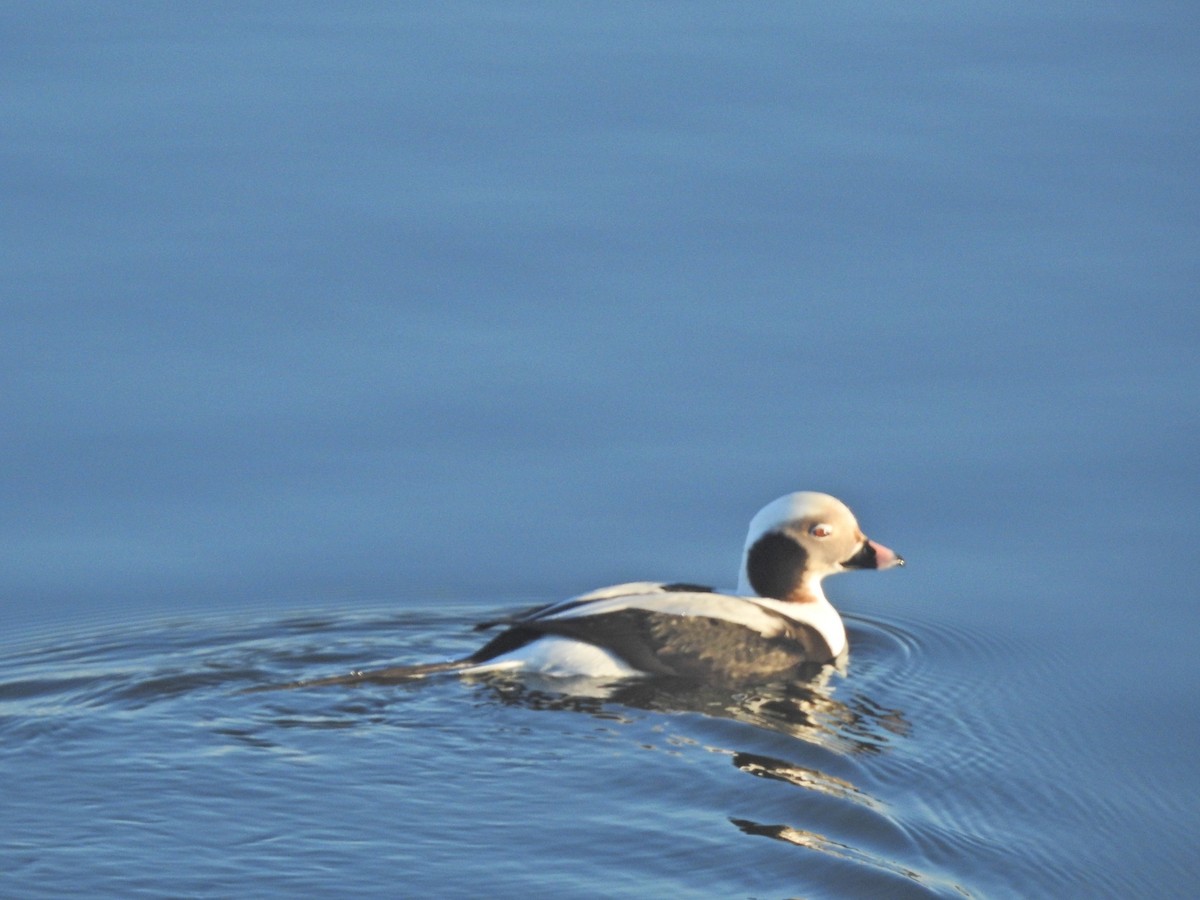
[738,491,904,602]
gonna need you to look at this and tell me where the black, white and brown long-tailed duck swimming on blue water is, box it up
[276,491,905,686]
